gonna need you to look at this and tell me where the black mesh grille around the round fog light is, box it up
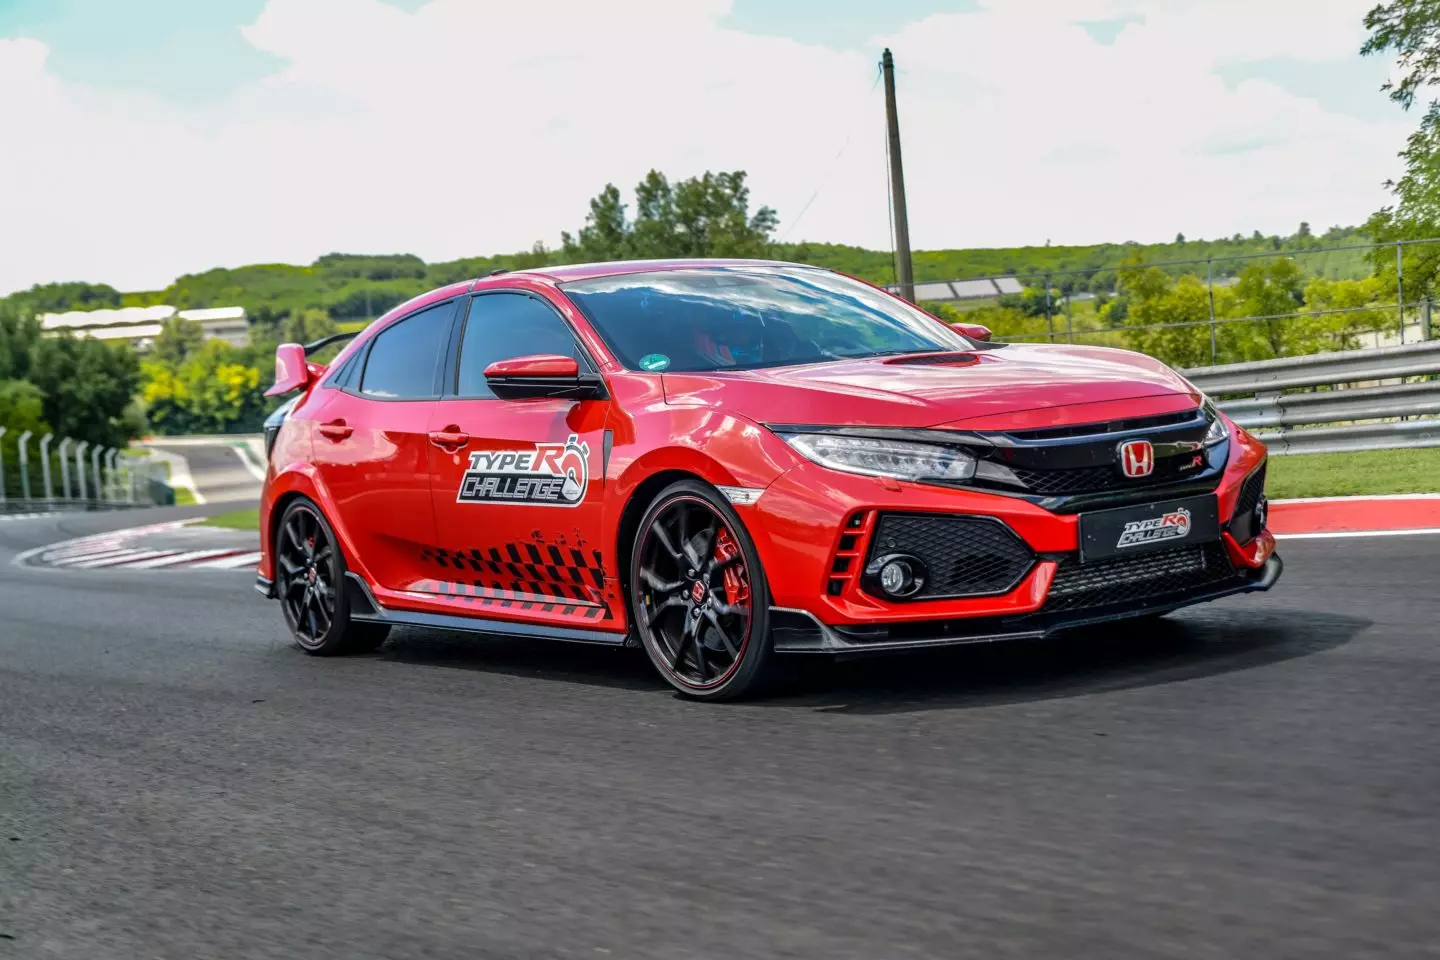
[870,514,1034,600]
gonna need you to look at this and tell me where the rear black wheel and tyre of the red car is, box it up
[274,498,390,656]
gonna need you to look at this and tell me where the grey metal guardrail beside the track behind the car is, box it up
[1181,341,1440,455]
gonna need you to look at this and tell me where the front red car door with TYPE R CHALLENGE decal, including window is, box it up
[431,289,615,629]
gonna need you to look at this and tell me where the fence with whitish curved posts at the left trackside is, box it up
[0,426,174,514]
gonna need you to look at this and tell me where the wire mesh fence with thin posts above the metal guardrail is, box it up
[916,237,1440,366]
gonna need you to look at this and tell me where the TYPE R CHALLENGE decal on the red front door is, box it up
[455,433,590,507]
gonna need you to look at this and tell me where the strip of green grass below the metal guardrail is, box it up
[1266,448,1440,499]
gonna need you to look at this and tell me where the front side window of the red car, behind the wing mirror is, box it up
[456,294,588,397]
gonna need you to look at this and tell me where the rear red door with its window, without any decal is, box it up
[311,301,456,590]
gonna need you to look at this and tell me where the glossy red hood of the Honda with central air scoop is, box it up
[664,344,1202,430]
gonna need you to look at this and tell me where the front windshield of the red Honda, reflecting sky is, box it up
[562,266,973,373]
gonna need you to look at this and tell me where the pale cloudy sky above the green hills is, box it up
[0,0,1418,294]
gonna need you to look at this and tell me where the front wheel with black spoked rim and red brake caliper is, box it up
[629,479,772,701]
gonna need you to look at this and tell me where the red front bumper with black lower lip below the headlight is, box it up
[742,429,1282,652]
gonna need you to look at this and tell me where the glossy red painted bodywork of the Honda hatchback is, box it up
[259,261,1284,632]
